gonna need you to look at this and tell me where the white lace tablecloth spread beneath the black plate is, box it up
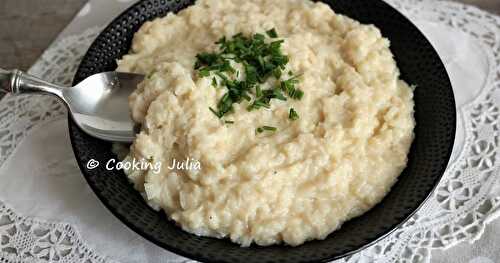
[0,0,500,263]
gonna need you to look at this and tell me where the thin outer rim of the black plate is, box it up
[68,0,456,263]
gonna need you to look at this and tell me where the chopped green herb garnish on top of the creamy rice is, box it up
[194,28,304,133]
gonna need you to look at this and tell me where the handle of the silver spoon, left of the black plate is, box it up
[0,68,62,98]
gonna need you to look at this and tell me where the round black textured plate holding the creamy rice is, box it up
[69,0,455,263]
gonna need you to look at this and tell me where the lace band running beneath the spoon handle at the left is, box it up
[0,28,101,169]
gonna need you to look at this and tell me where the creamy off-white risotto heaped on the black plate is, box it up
[118,0,415,249]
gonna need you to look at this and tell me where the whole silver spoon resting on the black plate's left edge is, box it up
[0,69,144,142]
